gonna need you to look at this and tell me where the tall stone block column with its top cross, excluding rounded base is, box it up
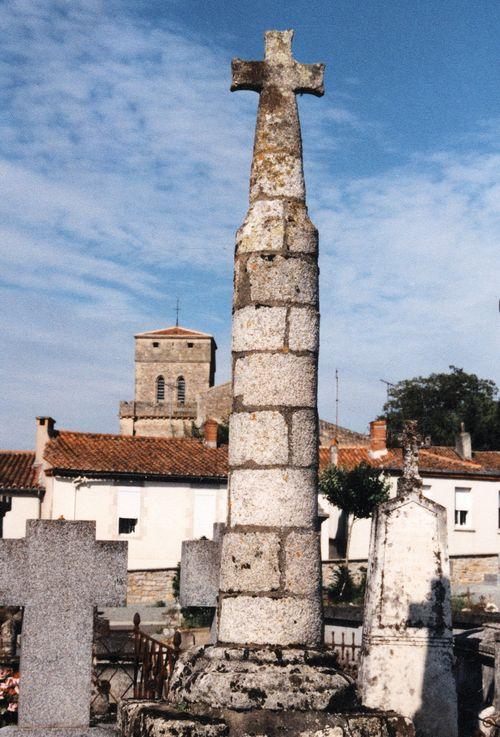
[219,31,323,646]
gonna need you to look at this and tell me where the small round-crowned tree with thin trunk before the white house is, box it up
[319,463,391,566]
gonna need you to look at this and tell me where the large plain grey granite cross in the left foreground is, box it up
[0,520,127,734]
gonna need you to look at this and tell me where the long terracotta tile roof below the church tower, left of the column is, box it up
[44,430,228,479]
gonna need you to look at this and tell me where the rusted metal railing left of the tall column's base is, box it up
[134,613,182,700]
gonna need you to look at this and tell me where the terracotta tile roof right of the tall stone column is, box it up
[319,446,500,476]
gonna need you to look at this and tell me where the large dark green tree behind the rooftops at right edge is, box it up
[380,366,500,450]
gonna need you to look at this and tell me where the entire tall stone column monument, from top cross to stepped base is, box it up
[120,31,410,737]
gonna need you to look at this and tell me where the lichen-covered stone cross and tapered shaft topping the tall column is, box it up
[231,31,324,202]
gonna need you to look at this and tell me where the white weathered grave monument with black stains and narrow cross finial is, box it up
[359,421,457,737]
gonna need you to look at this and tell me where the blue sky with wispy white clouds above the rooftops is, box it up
[0,0,500,448]
